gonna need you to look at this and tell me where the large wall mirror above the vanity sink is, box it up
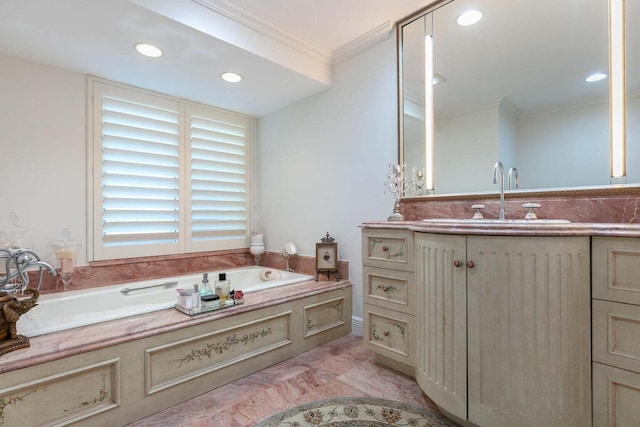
[398,0,640,196]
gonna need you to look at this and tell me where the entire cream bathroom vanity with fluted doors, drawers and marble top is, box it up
[362,220,640,427]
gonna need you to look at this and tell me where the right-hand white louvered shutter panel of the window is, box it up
[190,107,250,250]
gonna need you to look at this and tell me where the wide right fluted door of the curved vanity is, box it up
[466,236,591,427]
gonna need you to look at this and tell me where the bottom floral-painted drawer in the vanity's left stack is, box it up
[364,304,414,367]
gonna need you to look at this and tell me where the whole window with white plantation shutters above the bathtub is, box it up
[88,77,253,260]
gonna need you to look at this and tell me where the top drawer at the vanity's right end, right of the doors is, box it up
[591,236,640,304]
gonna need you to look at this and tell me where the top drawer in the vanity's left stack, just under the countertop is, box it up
[362,229,415,271]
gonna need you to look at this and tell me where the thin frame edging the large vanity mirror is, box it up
[396,0,640,202]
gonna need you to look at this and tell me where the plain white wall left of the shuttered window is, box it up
[0,55,86,264]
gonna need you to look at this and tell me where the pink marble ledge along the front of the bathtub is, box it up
[0,280,352,373]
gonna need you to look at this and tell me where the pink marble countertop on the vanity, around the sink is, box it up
[361,219,640,237]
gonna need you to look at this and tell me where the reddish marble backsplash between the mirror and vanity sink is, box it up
[400,188,640,224]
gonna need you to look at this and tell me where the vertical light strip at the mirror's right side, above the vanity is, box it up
[609,0,627,183]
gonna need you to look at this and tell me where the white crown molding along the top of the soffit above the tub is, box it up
[191,0,332,65]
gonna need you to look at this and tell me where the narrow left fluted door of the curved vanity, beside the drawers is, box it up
[415,233,467,419]
